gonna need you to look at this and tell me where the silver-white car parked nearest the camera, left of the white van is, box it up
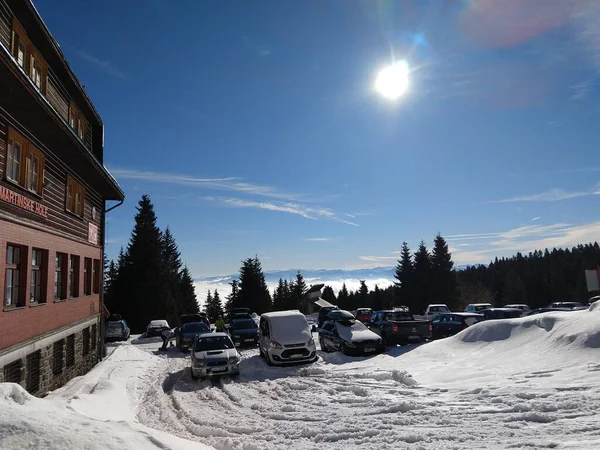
[191,333,240,380]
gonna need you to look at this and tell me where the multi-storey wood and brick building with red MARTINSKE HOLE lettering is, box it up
[0,0,124,395]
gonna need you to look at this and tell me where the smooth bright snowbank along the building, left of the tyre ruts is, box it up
[0,345,211,450]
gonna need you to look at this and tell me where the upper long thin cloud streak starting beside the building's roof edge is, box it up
[111,169,306,200]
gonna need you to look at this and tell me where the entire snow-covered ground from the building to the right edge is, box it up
[0,302,600,450]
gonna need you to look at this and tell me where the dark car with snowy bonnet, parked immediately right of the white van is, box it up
[318,310,385,355]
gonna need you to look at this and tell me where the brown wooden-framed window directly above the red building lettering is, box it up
[6,128,44,195]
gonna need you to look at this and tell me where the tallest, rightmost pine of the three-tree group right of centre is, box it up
[431,233,458,311]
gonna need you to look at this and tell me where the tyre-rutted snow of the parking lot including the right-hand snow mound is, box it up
[131,311,600,449]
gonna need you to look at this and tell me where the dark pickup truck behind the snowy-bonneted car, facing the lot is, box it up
[368,309,431,346]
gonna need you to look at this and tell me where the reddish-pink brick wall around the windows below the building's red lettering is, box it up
[0,216,102,355]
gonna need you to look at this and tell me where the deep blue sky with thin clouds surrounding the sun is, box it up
[35,0,600,276]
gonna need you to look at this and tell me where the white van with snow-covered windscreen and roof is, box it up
[258,310,317,365]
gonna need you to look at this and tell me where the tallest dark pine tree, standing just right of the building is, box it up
[115,195,170,333]
